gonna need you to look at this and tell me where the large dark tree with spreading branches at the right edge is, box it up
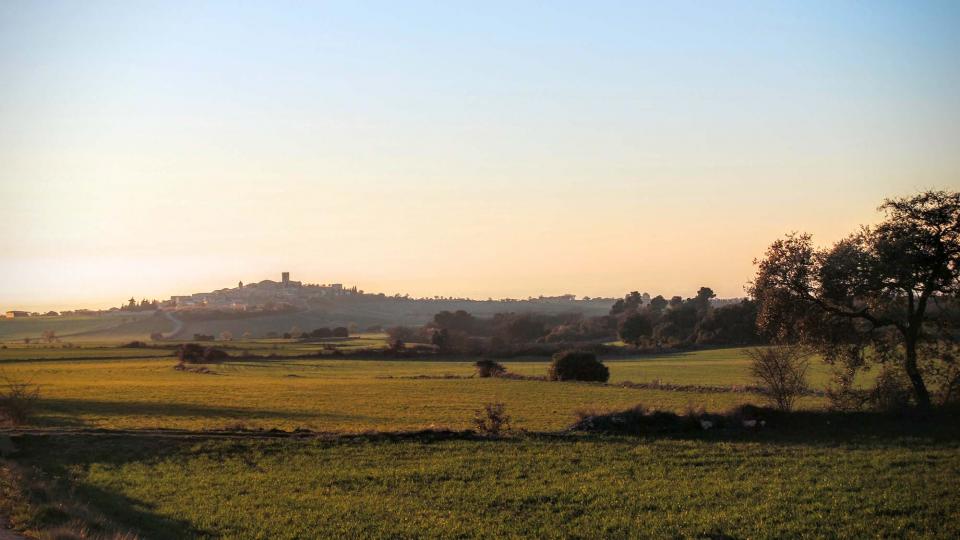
[750,191,960,408]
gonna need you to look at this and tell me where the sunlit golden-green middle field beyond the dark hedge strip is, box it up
[0,345,820,432]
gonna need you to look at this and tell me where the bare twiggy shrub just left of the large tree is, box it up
[747,345,810,411]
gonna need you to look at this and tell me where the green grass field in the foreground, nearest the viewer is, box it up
[9,426,960,538]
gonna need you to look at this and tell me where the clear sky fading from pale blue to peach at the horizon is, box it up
[0,0,960,309]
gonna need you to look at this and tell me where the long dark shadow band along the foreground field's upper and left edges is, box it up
[7,410,960,538]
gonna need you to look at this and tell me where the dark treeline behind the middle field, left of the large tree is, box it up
[387,287,762,355]
